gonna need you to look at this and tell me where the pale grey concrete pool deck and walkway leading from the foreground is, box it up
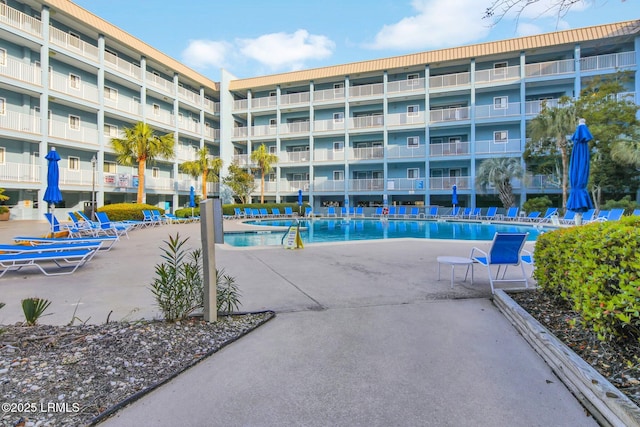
[0,221,596,426]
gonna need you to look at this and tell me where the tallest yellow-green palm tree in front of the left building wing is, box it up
[111,122,174,203]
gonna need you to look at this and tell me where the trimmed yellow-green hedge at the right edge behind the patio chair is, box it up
[534,217,640,340]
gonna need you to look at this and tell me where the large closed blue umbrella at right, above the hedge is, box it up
[567,119,593,212]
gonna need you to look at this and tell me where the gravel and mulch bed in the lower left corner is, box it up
[0,312,274,426]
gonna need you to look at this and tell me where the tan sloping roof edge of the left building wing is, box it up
[46,0,220,91]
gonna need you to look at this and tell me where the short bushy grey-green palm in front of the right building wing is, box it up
[476,157,524,209]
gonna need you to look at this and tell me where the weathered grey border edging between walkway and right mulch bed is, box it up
[493,289,640,426]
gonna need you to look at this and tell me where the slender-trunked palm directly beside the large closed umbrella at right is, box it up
[527,99,578,208]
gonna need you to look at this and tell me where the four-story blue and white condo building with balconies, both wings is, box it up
[0,0,640,218]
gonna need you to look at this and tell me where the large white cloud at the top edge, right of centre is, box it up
[365,0,492,50]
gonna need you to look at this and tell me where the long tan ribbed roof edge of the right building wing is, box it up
[229,20,640,91]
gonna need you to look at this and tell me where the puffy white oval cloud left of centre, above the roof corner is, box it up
[236,30,335,71]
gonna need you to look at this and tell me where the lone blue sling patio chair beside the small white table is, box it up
[465,233,529,294]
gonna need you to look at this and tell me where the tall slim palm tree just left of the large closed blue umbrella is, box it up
[524,97,578,208]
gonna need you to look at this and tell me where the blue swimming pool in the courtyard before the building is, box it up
[224,219,548,246]
